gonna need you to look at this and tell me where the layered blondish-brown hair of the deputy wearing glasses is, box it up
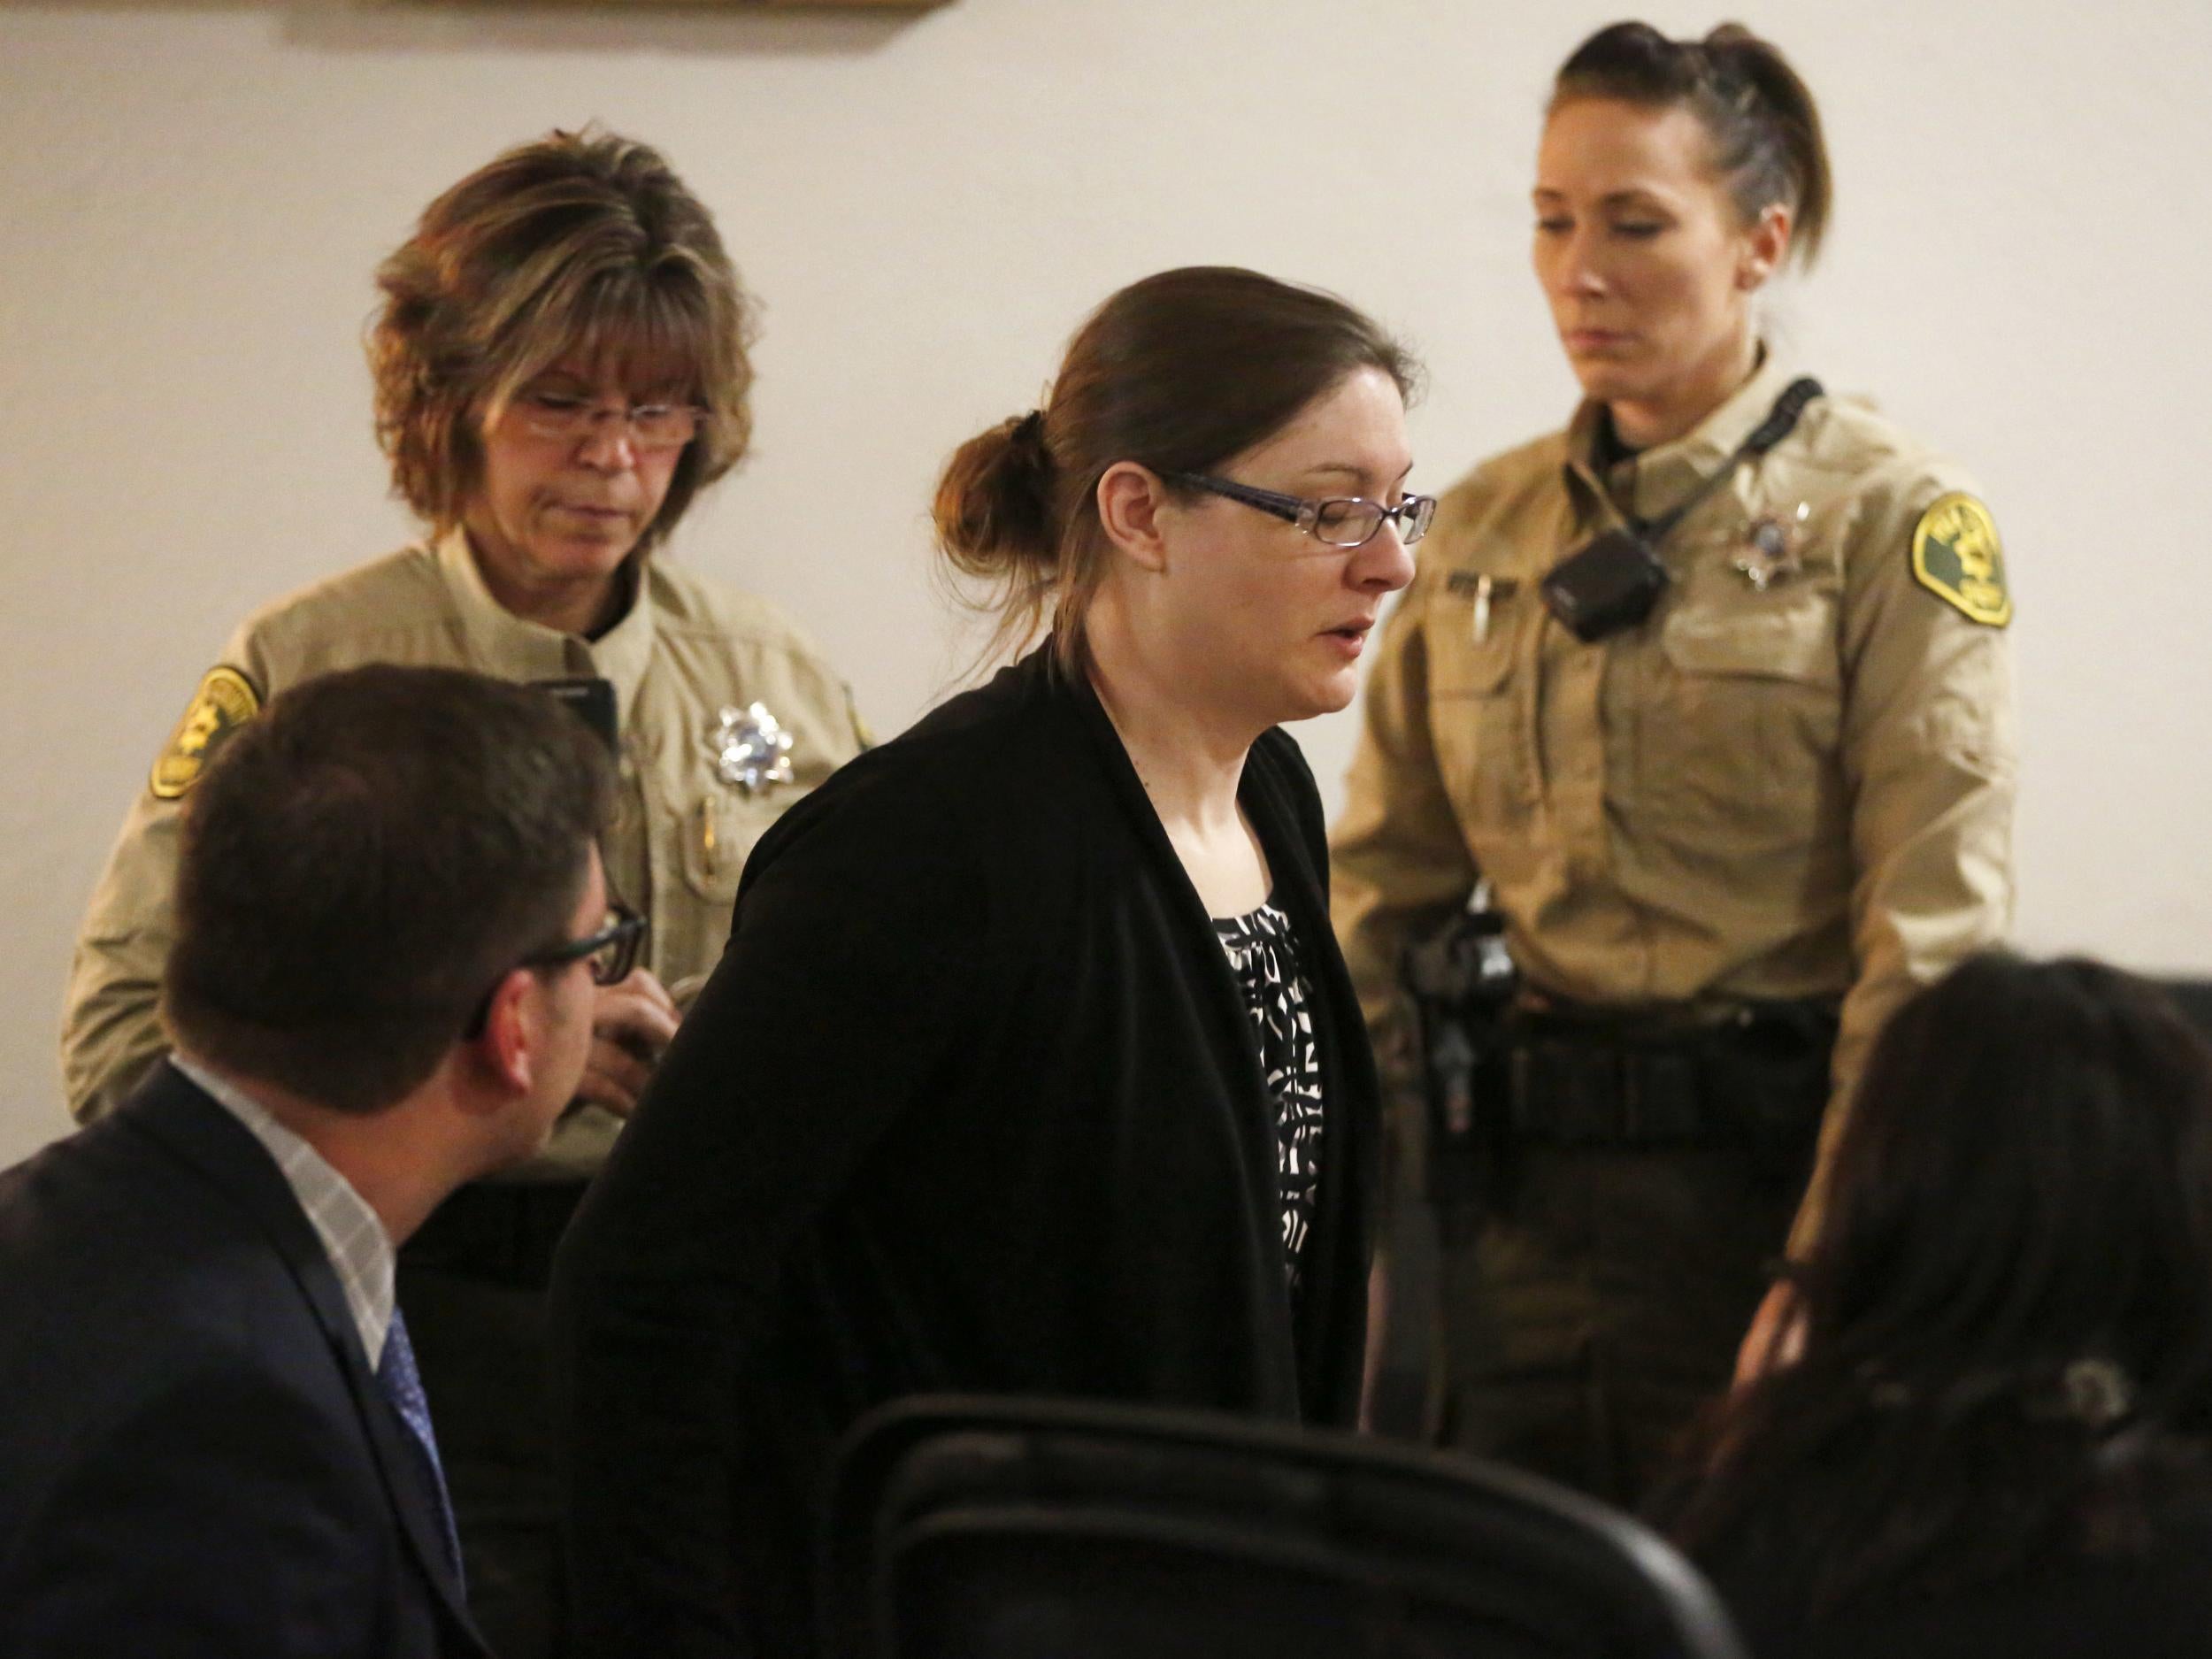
[367,128,755,551]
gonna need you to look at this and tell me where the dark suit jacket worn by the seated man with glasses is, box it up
[0,1064,485,1659]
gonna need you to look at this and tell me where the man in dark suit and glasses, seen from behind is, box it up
[0,668,640,1659]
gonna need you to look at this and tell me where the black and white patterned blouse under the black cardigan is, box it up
[1215,902,1321,1296]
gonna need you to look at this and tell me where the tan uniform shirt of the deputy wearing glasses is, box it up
[62,534,863,1179]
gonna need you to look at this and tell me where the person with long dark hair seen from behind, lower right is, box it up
[1662,954,2212,1659]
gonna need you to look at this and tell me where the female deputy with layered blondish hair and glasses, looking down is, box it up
[62,133,863,1655]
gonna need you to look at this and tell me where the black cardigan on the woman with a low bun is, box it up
[556,650,1379,1655]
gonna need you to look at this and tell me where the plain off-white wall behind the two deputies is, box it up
[0,0,2212,1162]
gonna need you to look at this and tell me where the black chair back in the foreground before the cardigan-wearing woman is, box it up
[823,1396,1743,1659]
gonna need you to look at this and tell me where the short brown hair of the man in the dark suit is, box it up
[162,664,613,1113]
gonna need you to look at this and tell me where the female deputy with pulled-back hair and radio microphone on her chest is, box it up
[1334,22,2013,1500]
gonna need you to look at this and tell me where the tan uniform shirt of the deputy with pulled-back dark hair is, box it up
[1334,357,2016,1243]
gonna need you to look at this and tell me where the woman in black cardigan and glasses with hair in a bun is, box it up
[556,268,1433,1655]
